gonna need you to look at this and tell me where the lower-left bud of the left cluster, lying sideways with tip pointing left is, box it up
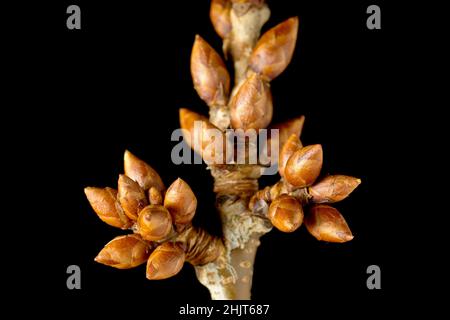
[95,234,150,269]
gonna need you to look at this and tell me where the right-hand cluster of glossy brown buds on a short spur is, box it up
[249,134,361,242]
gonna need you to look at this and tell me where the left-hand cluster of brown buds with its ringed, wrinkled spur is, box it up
[85,151,222,280]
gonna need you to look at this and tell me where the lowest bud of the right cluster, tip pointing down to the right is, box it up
[305,204,353,242]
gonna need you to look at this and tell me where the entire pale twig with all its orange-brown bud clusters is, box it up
[85,0,360,299]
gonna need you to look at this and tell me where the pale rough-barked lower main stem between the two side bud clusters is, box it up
[196,174,272,300]
